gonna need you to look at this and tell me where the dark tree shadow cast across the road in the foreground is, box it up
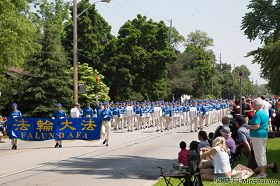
[37,156,176,180]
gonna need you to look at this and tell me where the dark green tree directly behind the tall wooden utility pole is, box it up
[64,0,113,70]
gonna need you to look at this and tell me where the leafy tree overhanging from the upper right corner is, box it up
[241,0,280,94]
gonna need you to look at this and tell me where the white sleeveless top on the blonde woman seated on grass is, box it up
[213,146,231,174]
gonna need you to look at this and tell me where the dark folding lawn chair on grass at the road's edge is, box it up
[158,150,203,186]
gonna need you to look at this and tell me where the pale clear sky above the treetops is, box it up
[90,0,267,84]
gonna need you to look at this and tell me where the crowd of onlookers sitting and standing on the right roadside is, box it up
[178,96,280,180]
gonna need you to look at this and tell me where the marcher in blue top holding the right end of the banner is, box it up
[101,102,112,146]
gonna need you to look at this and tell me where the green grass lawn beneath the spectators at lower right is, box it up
[154,138,280,186]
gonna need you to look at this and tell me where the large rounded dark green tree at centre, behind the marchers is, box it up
[101,15,176,100]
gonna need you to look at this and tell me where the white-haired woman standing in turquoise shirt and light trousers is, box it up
[245,98,268,178]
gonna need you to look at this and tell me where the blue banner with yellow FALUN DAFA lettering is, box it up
[7,118,102,141]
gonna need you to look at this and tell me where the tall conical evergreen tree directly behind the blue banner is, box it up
[21,0,73,117]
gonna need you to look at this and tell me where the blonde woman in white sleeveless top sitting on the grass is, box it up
[201,137,231,180]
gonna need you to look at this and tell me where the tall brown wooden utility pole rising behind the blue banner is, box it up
[73,0,78,103]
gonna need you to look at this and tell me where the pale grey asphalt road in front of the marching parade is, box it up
[0,124,221,186]
